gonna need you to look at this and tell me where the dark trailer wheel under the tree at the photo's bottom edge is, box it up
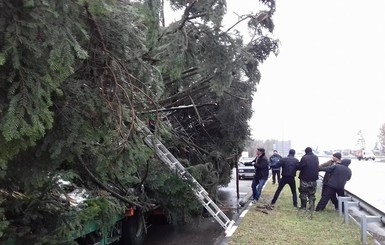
[120,211,146,245]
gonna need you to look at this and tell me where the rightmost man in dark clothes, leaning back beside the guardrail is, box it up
[316,159,352,211]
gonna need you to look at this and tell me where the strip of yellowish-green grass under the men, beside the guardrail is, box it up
[228,181,376,245]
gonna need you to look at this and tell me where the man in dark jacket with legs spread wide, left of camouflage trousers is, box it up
[271,149,299,207]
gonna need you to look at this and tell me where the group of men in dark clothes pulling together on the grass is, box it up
[251,147,352,211]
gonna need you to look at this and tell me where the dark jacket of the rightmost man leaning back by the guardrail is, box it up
[319,159,352,190]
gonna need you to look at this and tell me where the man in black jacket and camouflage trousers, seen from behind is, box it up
[298,147,319,211]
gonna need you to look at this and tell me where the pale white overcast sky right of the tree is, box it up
[228,0,385,149]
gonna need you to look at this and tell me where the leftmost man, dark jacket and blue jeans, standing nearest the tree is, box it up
[251,148,269,203]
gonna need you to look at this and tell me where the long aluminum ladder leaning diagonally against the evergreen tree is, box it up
[138,120,235,233]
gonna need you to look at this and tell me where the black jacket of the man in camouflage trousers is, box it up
[298,152,319,181]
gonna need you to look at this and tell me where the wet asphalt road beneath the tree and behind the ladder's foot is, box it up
[144,170,251,245]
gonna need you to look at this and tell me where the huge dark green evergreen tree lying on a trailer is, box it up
[0,0,278,241]
